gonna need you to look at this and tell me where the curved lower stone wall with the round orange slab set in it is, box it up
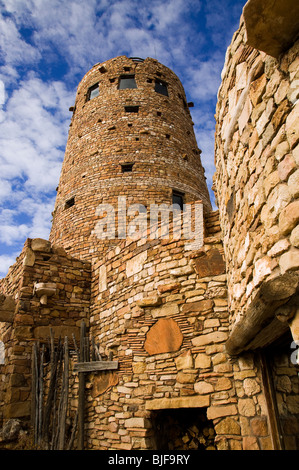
[79,212,271,450]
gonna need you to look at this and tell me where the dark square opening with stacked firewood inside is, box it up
[152,408,216,451]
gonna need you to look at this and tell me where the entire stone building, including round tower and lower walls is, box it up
[0,0,299,450]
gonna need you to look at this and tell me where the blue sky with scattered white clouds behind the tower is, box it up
[0,0,246,277]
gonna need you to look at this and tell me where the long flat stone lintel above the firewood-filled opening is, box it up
[145,395,210,410]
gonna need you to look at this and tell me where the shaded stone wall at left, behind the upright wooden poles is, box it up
[0,239,90,421]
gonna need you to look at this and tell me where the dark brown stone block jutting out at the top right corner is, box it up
[243,0,299,58]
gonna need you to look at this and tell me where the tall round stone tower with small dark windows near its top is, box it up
[50,56,211,259]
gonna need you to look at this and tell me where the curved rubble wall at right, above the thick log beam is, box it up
[214,17,299,338]
